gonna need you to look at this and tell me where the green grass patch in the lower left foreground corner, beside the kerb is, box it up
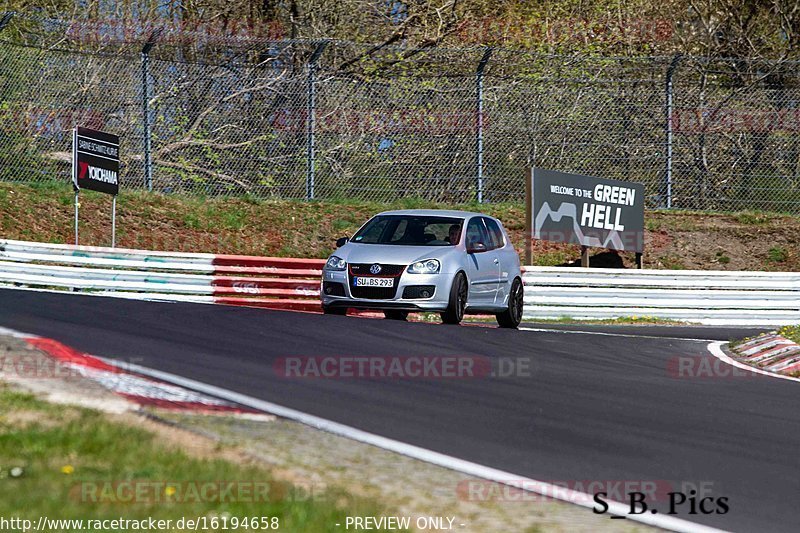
[0,385,400,531]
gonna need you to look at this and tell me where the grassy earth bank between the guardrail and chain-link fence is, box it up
[0,182,800,271]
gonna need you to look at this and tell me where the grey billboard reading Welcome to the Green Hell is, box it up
[527,168,644,252]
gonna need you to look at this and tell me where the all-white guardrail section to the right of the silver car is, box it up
[523,267,800,325]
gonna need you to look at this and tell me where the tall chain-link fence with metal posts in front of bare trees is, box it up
[0,17,800,213]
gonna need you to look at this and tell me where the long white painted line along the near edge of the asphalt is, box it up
[100,357,724,533]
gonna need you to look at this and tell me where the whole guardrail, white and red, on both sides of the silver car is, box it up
[0,240,800,325]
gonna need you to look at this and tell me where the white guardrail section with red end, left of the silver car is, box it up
[0,240,324,311]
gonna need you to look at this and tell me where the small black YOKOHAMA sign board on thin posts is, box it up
[72,126,119,196]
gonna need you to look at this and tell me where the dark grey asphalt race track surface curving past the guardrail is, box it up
[0,290,800,531]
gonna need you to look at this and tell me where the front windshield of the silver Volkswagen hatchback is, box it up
[352,215,464,246]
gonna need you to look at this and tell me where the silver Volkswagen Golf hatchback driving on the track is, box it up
[320,209,523,328]
